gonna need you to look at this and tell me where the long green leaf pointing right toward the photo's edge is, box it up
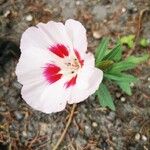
[109,54,149,73]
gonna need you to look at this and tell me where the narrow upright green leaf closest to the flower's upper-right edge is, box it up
[95,38,109,64]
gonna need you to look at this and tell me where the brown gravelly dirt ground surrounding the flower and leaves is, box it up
[0,0,150,150]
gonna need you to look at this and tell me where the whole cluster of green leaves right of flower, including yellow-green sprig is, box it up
[95,35,150,110]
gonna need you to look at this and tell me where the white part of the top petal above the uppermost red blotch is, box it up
[37,21,72,50]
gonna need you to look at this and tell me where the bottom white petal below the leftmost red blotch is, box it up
[22,77,69,113]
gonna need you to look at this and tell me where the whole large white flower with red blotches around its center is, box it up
[16,19,103,113]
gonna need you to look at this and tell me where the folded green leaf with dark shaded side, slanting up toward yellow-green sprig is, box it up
[103,43,122,61]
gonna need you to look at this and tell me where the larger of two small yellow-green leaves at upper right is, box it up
[120,34,135,48]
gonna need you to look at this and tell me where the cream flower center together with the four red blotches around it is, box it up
[43,44,84,88]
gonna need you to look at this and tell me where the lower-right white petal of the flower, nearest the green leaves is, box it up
[68,68,103,104]
